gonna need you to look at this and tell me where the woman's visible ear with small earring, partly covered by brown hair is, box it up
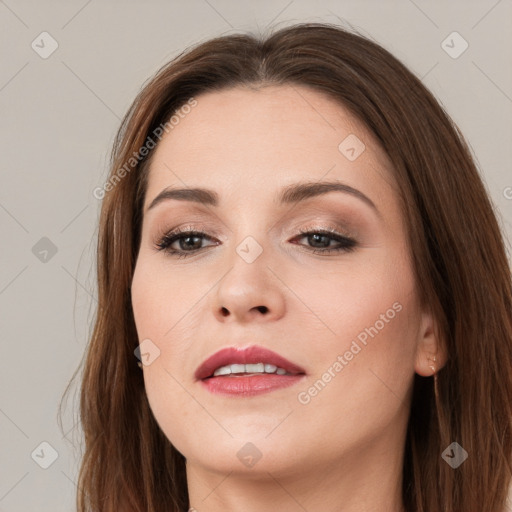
[414,311,448,377]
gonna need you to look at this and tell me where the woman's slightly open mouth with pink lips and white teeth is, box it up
[195,345,306,396]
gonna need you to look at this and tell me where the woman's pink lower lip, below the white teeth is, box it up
[201,374,305,397]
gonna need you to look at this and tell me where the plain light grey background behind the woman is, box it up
[0,0,512,512]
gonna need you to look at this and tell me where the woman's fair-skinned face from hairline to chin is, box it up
[131,86,433,484]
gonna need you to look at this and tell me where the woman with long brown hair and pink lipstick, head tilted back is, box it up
[64,24,512,512]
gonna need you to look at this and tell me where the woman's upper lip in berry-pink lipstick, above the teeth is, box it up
[194,345,306,380]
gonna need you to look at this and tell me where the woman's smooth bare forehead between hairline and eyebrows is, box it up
[146,85,391,209]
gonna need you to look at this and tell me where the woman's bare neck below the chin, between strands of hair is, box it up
[187,439,404,512]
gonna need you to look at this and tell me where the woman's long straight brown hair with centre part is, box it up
[60,23,512,512]
